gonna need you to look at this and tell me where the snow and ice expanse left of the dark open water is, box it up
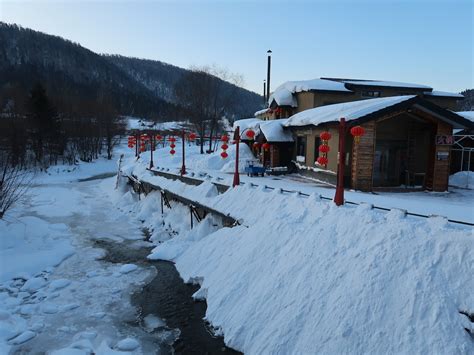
[0,151,167,354]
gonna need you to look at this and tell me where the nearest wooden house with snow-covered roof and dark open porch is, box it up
[284,95,472,191]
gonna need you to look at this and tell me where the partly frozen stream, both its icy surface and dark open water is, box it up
[11,174,241,354]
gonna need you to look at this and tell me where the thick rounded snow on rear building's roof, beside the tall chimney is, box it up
[268,79,352,107]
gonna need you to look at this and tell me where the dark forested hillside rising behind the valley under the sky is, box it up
[0,22,262,120]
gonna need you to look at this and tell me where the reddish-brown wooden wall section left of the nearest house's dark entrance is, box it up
[351,121,375,191]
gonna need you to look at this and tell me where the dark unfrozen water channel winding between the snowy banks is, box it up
[96,241,244,354]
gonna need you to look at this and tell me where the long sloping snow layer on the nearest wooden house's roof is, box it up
[285,95,416,127]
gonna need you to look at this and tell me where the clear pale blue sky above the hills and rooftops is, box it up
[0,0,474,93]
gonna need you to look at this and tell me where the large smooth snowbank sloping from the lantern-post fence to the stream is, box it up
[120,177,474,354]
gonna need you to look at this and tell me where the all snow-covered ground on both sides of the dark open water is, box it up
[0,138,474,354]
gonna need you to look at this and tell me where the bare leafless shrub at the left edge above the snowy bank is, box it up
[0,152,33,219]
